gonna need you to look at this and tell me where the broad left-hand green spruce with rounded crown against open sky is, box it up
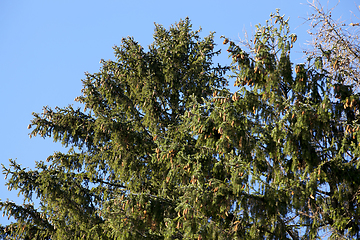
[1,19,226,239]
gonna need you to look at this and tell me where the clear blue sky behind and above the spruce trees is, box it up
[0,0,359,224]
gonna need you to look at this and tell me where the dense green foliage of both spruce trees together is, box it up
[0,13,360,239]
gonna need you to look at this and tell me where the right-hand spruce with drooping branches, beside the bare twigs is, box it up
[202,12,360,239]
